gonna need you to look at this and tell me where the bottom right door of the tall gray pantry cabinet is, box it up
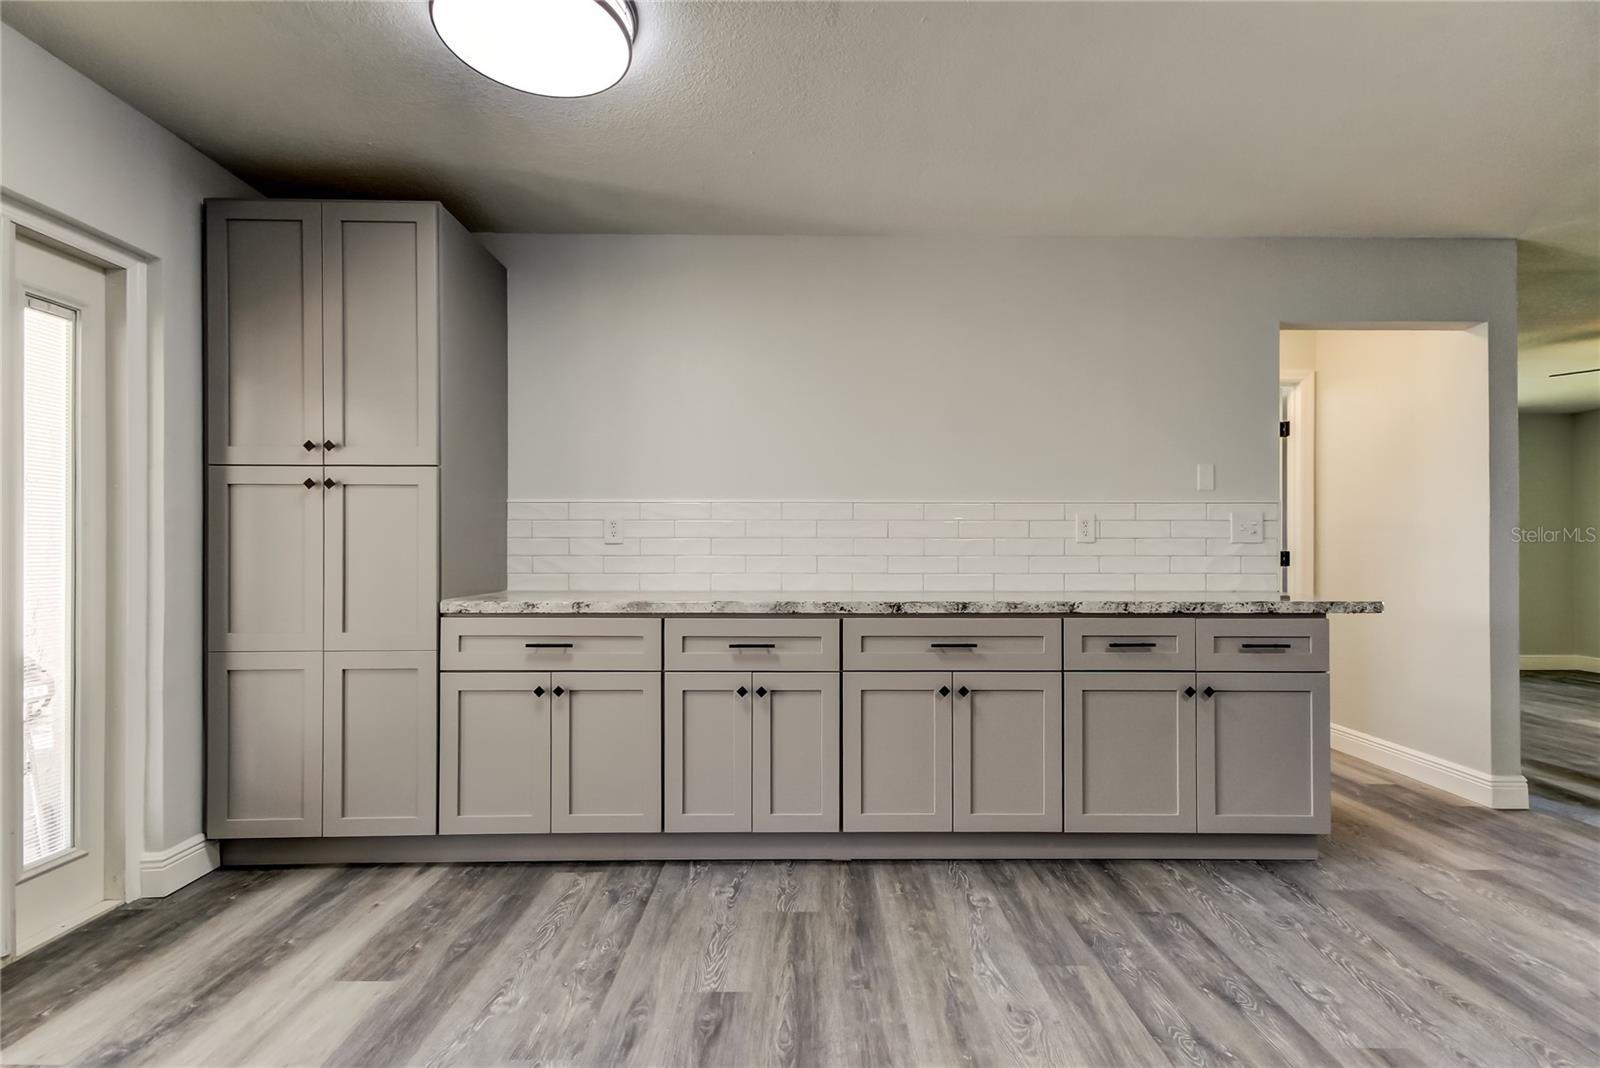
[322,652,438,836]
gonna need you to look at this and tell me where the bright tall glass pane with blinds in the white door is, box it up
[22,297,77,868]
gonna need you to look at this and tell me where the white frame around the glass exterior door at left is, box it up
[0,197,152,956]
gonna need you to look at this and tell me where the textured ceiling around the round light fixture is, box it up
[0,0,1600,404]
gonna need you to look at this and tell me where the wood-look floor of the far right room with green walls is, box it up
[1522,671,1600,815]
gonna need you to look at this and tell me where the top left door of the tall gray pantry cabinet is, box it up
[205,200,323,464]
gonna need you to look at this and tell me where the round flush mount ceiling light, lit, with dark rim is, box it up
[429,0,637,96]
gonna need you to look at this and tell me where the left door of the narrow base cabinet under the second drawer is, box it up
[662,671,752,831]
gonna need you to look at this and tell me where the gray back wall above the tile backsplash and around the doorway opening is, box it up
[488,235,1520,774]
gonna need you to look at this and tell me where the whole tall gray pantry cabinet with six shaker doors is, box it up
[205,200,506,838]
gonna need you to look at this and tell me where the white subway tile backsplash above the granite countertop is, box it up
[506,500,1282,593]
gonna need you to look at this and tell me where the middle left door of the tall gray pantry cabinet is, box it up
[206,467,325,652]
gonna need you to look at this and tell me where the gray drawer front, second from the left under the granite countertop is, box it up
[666,617,838,671]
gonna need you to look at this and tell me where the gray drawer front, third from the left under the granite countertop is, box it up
[843,617,1061,671]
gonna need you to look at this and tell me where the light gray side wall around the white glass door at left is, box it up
[0,26,254,851]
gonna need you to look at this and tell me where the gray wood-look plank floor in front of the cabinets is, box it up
[0,756,1600,1068]
